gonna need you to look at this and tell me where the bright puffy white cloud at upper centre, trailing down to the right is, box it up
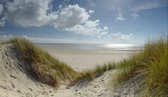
[55,5,108,37]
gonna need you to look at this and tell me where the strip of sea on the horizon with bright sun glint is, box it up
[37,43,143,51]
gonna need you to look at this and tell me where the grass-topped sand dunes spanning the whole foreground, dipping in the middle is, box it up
[0,38,168,97]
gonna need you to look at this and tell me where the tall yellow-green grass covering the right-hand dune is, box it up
[116,37,168,97]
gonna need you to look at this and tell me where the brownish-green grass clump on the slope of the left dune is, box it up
[10,38,78,86]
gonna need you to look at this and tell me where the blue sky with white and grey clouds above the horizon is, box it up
[0,0,168,44]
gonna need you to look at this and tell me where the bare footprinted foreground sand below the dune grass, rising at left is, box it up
[0,44,139,97]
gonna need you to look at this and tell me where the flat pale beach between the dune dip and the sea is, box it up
[43,48,135,71]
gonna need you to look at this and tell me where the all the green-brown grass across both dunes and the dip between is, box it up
[7,37,168,97]
